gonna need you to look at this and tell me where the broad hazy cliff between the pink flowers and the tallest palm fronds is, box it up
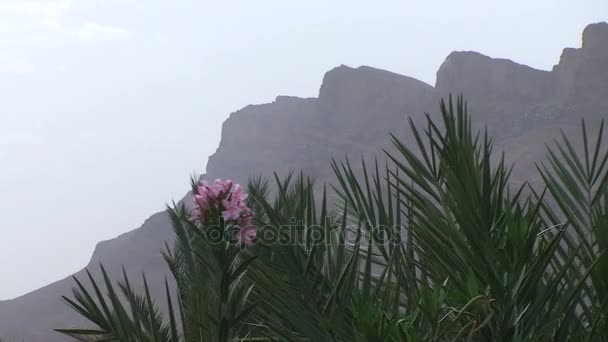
[206,66,437,186]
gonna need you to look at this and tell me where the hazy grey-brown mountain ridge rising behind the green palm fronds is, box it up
[0,23,608,342]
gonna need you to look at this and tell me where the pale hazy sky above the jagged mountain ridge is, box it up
[0,0,608,299]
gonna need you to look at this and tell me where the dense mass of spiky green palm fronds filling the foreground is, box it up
[54,98,608,342]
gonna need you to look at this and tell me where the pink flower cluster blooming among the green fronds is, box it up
[191,179,257,245]
